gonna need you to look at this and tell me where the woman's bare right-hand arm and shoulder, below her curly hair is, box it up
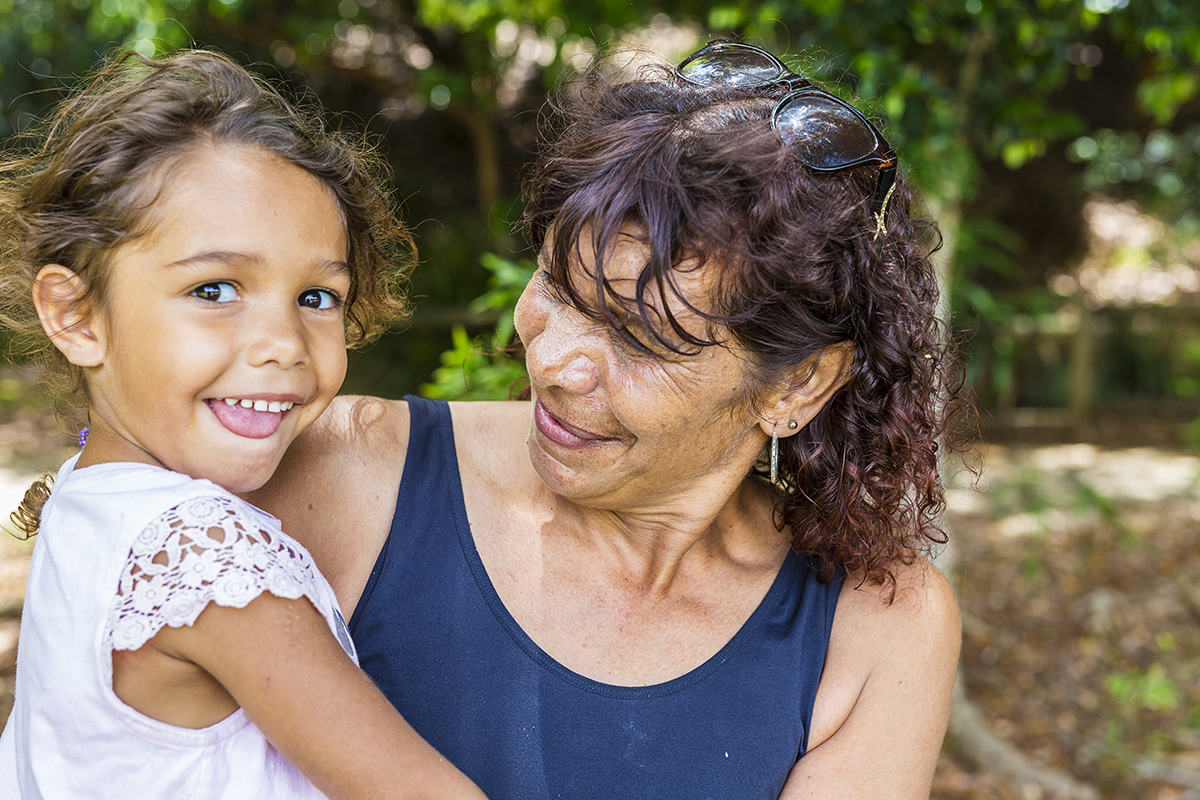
[780,560,961,800]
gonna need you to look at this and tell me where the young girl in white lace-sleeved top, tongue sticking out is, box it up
[0,52,482,800]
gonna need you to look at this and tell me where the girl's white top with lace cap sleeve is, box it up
[0,458,355,800]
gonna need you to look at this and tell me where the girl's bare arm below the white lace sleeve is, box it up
[146,594,484,800]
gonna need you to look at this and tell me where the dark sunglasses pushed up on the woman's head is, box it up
[676,41,896,236]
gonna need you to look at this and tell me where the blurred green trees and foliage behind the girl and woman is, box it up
[0,0,1200,421]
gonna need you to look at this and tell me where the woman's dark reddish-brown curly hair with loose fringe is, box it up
[526,54,961,589]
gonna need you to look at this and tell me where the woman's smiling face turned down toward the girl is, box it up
[516,227,766,510]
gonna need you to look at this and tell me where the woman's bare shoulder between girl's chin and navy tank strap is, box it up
[244,397,408,619]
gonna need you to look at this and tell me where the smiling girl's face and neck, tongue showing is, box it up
[73,145,350,492]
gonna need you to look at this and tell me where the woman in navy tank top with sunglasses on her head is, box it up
[248,43,959,800]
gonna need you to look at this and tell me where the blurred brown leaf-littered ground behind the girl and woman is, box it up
[0,402,1200,800]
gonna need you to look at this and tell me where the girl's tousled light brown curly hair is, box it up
[0,50,415,533]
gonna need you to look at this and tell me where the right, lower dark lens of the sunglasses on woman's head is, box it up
[775,95,878,169]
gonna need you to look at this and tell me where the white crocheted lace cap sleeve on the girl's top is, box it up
[107,495,322,650]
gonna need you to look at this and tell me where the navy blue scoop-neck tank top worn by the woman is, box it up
[349,397,841,800]
